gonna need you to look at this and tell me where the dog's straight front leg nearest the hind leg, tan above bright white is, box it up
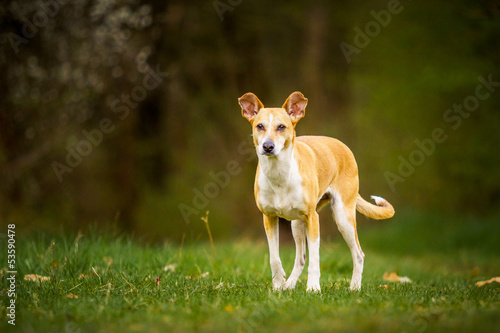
[306,211,321,292]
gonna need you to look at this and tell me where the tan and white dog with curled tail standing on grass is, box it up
[238,92,394,292]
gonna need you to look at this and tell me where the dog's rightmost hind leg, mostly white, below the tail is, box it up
[332,193,365,290]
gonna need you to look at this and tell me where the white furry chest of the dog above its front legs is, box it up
[258,155,306,220]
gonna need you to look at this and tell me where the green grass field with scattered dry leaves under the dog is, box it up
[0,212,500,333]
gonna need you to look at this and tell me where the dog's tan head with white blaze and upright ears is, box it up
[238,91,307,156]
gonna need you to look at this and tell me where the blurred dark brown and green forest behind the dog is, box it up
[0,0,500,241]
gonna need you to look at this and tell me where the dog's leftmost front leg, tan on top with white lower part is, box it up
[264,215,286,290]
